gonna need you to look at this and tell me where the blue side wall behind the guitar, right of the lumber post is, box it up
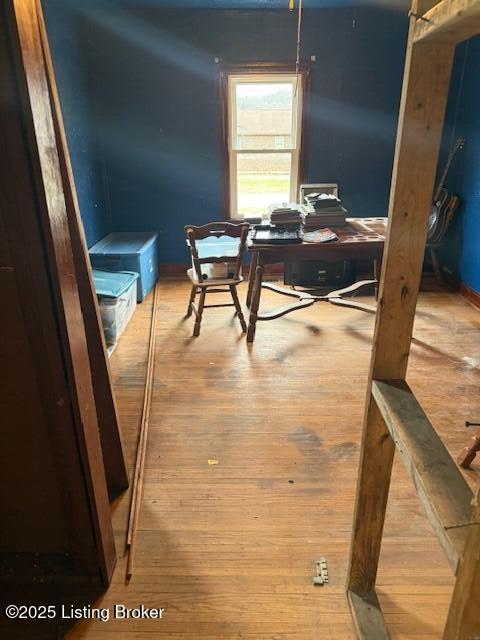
[443,36,480,293]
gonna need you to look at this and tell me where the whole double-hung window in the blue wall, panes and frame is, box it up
[228,73,302,218]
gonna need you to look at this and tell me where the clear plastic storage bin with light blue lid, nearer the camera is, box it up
[93,269,138,345]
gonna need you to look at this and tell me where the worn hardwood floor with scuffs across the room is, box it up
[68,280,480,640]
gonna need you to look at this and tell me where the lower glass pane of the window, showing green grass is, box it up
[237,153,292,217]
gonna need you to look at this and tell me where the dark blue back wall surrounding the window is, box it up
[43,0,407,263]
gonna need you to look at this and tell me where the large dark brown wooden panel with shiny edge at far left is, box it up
[0,0,126,584]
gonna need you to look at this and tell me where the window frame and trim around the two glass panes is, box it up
[227,71,303,220]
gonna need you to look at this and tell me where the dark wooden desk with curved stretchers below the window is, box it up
[247,218,387,342]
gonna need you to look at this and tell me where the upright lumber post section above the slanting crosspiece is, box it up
[372,44,454,379]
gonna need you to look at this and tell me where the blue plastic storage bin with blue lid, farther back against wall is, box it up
[88,231,158,302]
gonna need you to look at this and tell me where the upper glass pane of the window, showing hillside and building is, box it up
[233,82,295,149]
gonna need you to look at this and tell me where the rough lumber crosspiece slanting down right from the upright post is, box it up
[373,380,473,573]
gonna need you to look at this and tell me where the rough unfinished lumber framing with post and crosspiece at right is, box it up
[347,0,480,640]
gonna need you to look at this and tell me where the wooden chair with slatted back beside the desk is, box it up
[185,222,249,336]
